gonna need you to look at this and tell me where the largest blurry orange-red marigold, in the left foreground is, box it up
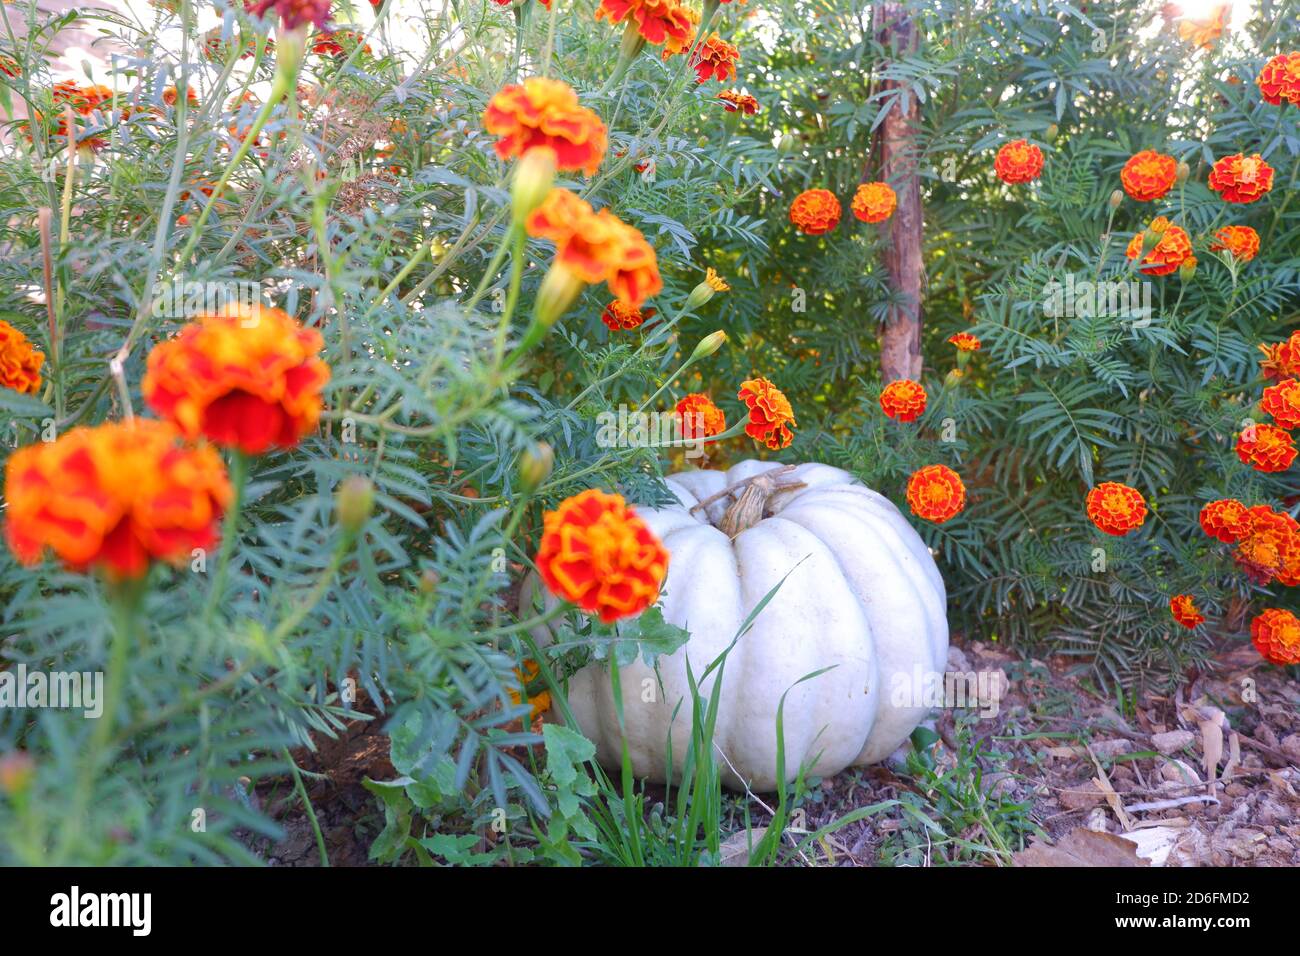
[4,419,231,580]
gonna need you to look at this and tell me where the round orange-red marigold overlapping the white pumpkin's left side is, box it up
[537,488,668,623]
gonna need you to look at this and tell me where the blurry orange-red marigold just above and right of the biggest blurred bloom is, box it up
[140,306,329,455]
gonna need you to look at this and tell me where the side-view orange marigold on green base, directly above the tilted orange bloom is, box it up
[484,77,608,176]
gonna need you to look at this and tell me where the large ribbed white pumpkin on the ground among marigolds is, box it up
[523,460,948,791]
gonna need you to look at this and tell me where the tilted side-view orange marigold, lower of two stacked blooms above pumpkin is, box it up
[524,187,663,308]
